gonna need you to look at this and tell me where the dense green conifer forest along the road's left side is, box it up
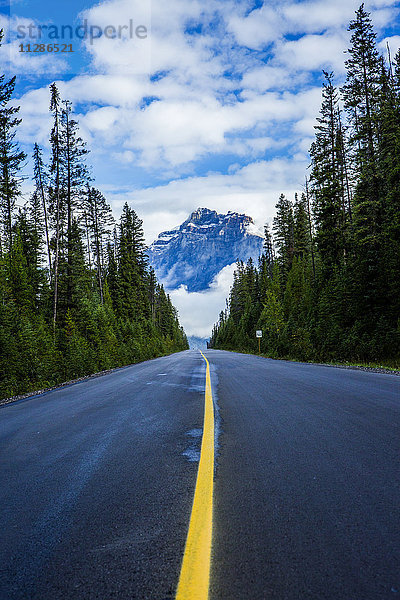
[0,64,188,397]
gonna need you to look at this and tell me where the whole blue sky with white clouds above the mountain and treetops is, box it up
[0,0,400,338]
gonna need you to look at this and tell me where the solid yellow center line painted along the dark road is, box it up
[176,352,214,600]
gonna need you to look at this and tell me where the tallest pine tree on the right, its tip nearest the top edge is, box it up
[343,5,385,324]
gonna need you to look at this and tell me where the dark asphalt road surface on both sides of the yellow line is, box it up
[0,350,400,600]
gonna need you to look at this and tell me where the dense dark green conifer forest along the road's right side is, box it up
[211,6,400,364]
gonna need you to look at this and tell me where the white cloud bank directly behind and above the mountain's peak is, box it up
[102,157,308,244]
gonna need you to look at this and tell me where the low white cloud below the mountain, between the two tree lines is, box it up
[170,264,236,338]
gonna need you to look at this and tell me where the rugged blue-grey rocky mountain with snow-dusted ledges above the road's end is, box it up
[148,208,263,292]
